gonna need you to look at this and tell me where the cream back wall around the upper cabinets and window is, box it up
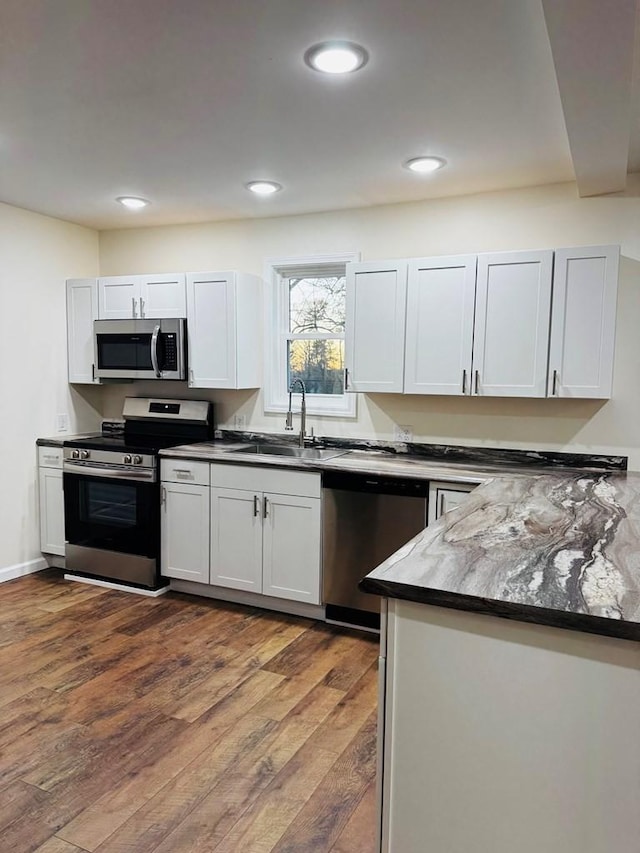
[100,176,640,468]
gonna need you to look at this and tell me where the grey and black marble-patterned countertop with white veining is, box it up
[38,433,640,640]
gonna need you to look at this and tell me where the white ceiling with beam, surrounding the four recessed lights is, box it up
[0,0,640,229]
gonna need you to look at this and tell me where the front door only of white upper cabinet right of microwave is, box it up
[187,273,236,388]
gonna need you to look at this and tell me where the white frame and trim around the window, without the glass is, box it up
[264,252,360,418]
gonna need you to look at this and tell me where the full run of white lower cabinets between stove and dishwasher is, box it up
[161,459,321,605]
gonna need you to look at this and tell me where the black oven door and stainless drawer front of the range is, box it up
[63,471,160,586]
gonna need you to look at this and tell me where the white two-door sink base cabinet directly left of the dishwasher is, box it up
[210,465,321,604]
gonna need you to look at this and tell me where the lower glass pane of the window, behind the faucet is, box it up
[287,339,344,394]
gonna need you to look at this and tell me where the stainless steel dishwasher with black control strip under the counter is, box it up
[322,471,429,628]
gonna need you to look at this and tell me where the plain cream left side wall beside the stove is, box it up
[0,204,100,579]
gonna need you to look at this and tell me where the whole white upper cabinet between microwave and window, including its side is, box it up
[187,272,263,388]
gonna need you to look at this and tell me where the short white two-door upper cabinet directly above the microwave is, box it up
[98,273,187,320]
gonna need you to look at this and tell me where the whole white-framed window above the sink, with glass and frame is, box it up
[265,255,358,417]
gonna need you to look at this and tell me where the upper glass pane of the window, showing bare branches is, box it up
[289,275,345,334]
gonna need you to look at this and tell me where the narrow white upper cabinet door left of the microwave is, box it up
[67,278,99,384]
